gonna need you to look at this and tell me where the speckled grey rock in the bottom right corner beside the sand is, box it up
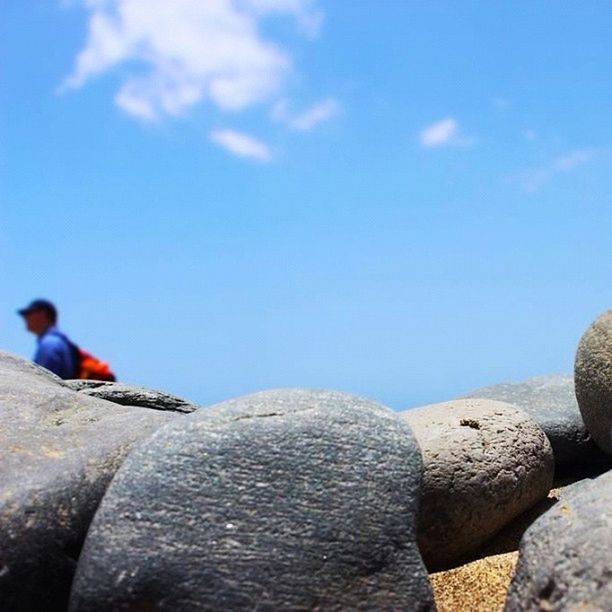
[504,472,612,612]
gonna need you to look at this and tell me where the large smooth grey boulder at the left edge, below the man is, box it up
[0,352,180,612]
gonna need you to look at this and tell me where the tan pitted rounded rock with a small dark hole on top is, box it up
[399,399,554,570]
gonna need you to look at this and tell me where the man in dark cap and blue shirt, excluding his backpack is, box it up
[17,300,76,378]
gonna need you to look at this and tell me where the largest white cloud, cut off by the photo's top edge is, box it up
[64,0,321,121]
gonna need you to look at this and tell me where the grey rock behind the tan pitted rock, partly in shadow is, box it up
[461,374,609,466]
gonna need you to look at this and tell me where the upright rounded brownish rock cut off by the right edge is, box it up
[574,310,612,455]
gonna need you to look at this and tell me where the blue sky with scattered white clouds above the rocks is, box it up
[0,0,612,408]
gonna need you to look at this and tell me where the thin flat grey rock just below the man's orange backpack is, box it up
[65,379,198,413]
